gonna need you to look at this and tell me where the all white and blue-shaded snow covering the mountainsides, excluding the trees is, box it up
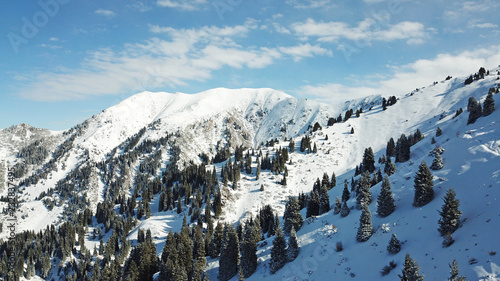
[0,71,500,280]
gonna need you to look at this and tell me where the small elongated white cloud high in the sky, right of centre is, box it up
[292,18,429,44]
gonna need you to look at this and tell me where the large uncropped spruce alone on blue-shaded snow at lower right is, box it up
[438,188,462,236]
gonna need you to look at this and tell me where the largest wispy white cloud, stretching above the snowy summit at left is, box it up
[18,20,331,101]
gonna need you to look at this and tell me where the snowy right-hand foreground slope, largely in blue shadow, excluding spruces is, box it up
[215,76,500,280]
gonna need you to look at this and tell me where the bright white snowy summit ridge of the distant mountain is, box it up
[77,88,333,160]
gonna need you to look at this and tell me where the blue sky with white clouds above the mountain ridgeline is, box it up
[0,0,500,130]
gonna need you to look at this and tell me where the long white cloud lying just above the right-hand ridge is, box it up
[298,45,500,102]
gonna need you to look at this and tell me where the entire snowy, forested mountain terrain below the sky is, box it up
[0,69,500,280]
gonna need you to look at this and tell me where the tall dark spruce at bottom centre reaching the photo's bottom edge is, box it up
[219,224,240,281]
